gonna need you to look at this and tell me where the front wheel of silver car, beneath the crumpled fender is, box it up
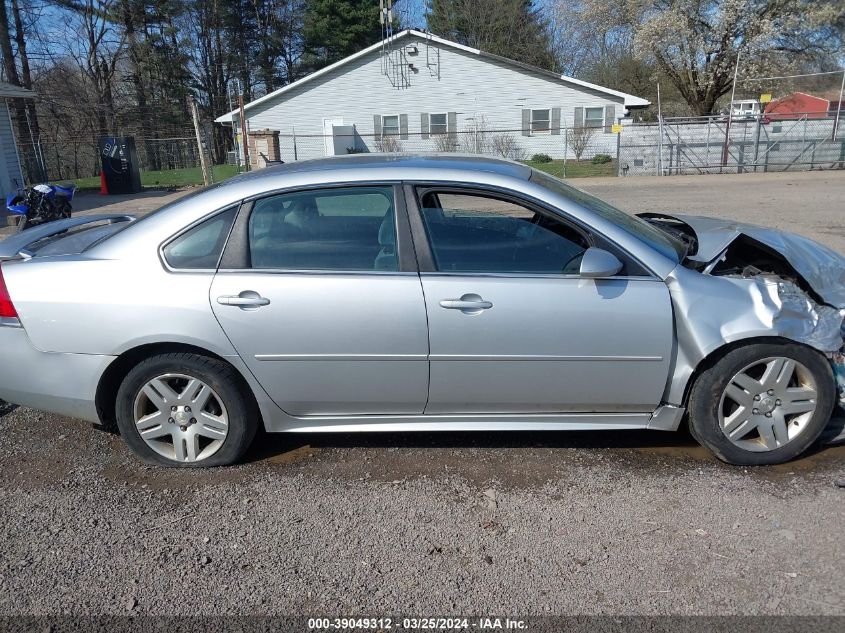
[689,343,836,466]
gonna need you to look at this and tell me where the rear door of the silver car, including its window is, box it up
[211,184,428,416]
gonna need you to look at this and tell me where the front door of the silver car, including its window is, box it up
[408,189,672,414]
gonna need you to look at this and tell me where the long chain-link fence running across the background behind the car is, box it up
[18,114,845,186]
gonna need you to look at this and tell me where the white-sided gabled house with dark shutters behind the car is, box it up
[217,30,649,161]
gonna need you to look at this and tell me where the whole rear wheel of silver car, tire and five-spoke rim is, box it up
[116,353,259,467]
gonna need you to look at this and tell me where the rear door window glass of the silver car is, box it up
[249,187,399,271]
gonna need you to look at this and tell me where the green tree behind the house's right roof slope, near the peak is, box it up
[426,0,558,70]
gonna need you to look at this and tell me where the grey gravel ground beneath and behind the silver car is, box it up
[0,174,845,616]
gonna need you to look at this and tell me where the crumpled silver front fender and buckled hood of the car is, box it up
[639,213,845,409]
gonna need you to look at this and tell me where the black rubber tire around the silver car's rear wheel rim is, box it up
[115,352,260,468]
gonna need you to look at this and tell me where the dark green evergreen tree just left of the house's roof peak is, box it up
[302,0,382,69]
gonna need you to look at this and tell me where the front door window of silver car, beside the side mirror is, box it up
[420,191,589,275]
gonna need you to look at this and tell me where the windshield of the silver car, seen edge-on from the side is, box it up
[530,169,687,261]
